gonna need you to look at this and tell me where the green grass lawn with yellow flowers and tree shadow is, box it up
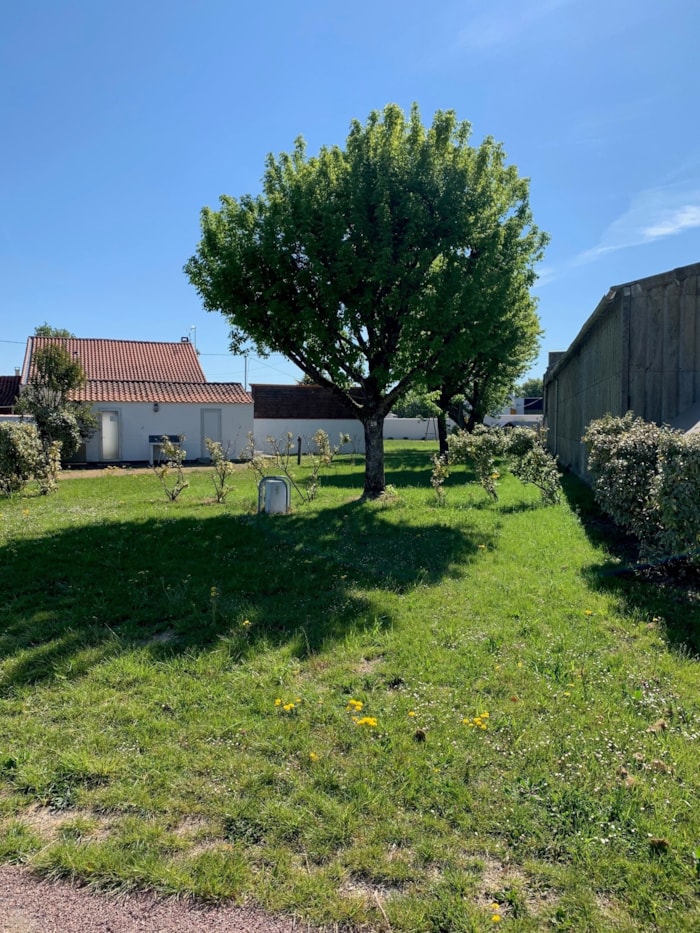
[0,442,700,933]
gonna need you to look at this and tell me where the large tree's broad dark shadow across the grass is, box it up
[0,503,489,695]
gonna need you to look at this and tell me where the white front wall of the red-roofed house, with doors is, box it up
[85,402,253,463]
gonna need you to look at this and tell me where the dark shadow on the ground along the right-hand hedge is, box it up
[562,473,700,655]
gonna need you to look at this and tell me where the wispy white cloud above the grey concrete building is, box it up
[576,181,700,264]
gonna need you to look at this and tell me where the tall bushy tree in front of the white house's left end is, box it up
[15,343,97,460]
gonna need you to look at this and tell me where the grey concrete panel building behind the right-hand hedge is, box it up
[544,263,700,478]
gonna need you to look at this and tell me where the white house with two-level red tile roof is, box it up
[21,337,253,463]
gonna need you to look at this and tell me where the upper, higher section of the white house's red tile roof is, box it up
[22,337,207,383]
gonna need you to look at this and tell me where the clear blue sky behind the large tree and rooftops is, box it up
[0,0,700,382]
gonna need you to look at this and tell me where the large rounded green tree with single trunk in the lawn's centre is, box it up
[185,104,544,497]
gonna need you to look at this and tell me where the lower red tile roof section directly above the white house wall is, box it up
[71,379,253,405]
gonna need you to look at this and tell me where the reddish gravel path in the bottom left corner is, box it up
[0,865,311,933]
